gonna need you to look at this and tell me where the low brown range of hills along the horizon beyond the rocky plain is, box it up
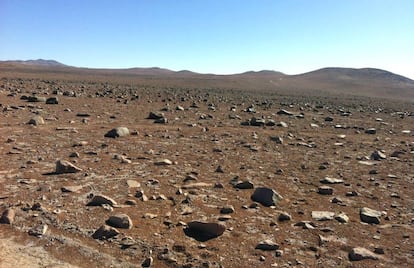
[0,59,414,102]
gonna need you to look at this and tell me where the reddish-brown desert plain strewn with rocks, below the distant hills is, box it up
[0,78,414,267]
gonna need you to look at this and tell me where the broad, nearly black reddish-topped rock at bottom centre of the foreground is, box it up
[184,221,226,241]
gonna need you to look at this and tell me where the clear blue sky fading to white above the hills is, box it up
[0,0,414,79]
